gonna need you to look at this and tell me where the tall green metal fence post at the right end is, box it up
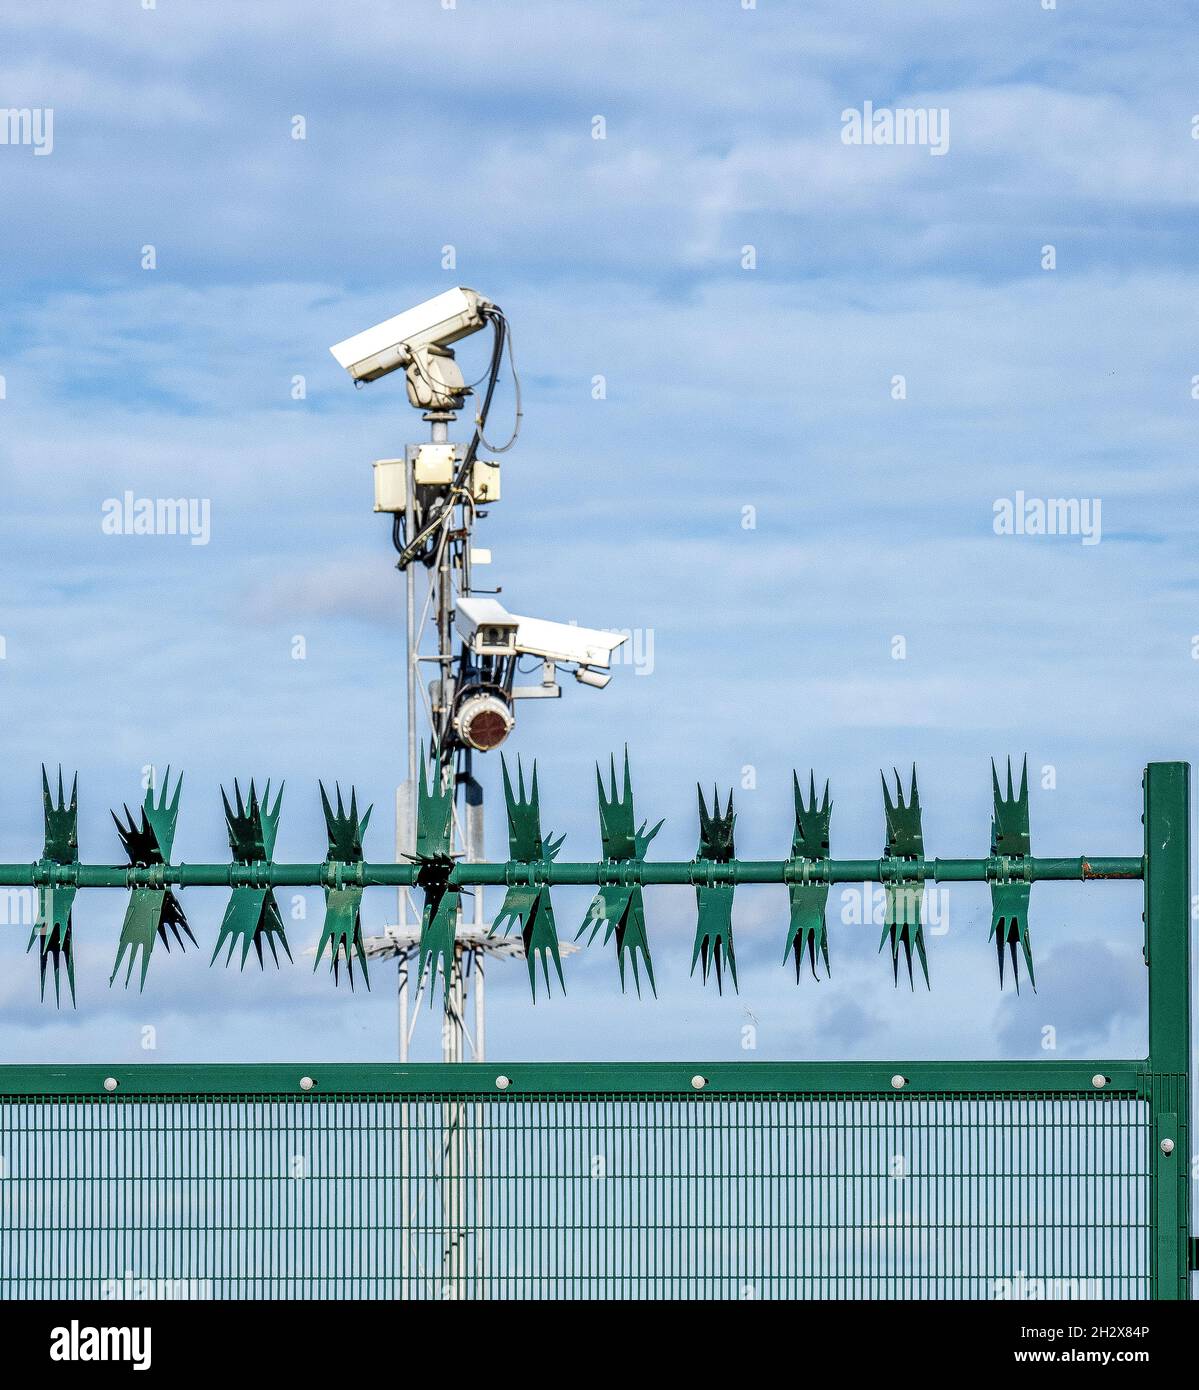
[1145,763,1191,1298]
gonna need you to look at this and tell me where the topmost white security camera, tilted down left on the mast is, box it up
[329,285,495,410]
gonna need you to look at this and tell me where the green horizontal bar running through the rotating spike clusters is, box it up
[0,855,1145,888]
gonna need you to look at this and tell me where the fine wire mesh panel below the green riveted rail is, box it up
[0,1093,1152,1298]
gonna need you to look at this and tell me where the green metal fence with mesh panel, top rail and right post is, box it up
[0,763,1191,1298]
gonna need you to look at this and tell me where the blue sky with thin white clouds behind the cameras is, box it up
[0,0,1199,1061]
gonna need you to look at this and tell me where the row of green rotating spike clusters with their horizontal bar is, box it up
[0,748,1146,1005]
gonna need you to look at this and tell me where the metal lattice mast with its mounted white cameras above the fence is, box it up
[331,285,597,1062]
